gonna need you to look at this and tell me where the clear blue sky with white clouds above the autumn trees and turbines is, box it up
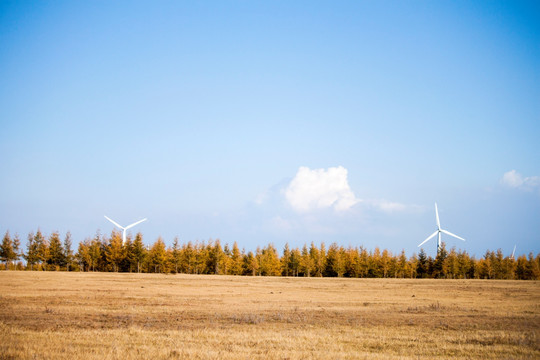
[0,1,540,255]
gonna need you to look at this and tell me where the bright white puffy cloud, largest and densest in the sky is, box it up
[285,166,360,212]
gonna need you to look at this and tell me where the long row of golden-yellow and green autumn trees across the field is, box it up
[0,230,540,280]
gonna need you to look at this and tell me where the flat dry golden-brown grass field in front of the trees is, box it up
[0,271,540,359]
